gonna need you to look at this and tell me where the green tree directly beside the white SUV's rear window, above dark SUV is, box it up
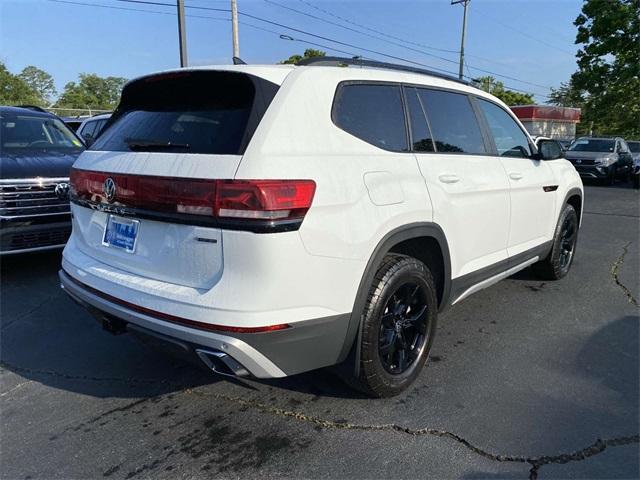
[56,73,127,110]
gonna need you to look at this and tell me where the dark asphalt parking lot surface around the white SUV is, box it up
[0,186,640,479]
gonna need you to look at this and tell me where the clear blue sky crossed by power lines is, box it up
[0,0,582,103]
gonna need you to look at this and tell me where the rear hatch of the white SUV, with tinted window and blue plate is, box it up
[71,70,286,289]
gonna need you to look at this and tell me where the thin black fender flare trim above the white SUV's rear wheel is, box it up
[338,222,451,368]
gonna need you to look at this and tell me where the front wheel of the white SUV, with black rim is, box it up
[533,205,578,280]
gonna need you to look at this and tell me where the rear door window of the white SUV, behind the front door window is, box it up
[416,88,487,154]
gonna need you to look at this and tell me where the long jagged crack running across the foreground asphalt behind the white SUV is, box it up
[0,362,640,480]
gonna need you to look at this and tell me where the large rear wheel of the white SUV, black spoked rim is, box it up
[349,254,438,398]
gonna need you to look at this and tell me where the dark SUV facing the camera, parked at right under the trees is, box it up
[565,137,633,185]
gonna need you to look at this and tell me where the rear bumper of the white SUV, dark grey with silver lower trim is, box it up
[59,270,350,378]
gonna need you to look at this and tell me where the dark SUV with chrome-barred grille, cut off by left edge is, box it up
[0,107,84,255]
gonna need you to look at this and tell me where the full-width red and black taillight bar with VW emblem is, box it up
[71,169,316,232]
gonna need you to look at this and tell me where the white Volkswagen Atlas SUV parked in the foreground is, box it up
[60,58,583,396]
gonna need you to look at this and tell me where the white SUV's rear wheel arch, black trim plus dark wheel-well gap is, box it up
[339,222,451,366]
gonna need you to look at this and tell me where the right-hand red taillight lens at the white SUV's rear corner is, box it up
[216,180,316,220]
